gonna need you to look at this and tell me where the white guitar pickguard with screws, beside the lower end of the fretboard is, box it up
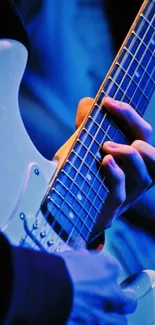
[2,161,69,252]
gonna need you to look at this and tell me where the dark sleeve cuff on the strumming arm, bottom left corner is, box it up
[0,234,73,325]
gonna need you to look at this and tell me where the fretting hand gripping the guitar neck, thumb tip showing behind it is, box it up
[76,98,155,229]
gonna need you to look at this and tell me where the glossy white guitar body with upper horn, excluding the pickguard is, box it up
[0,40,55,233]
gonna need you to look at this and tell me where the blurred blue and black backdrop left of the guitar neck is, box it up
[15,0,155,159]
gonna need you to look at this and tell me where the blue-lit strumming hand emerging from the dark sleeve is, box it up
[62,251,137,325]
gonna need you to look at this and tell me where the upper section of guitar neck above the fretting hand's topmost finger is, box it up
[96,0,155,116]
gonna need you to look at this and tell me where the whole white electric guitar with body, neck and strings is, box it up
[0,0,155,325]
